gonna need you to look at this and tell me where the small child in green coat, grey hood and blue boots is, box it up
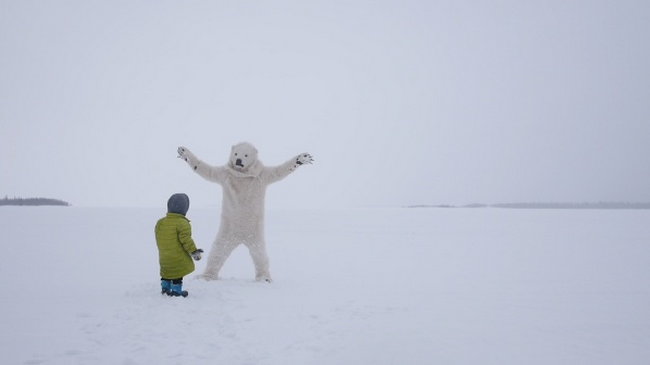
[155,193,203,297]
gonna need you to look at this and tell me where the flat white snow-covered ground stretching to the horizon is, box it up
[0,207,650,365]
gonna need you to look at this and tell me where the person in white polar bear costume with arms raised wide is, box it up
[178,142,313,283]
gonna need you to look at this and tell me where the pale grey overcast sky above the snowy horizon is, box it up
[0,0,650,207]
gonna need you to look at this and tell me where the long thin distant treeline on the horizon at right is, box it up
[409,202,650,209]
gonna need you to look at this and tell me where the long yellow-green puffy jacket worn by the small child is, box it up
[156,213,196,279]
